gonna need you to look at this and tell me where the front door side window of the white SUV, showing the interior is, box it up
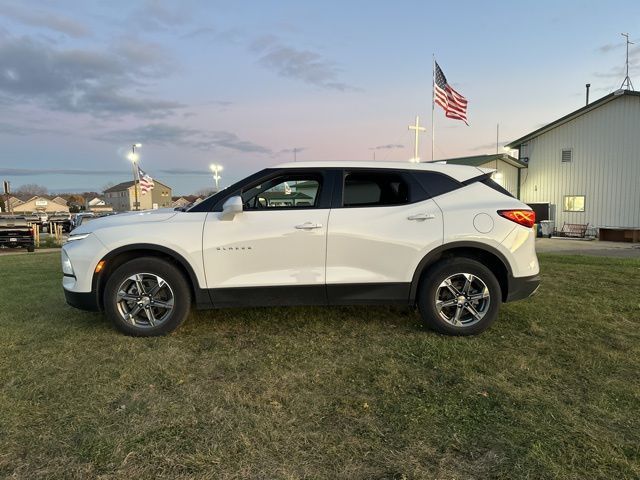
[242,175,321,210]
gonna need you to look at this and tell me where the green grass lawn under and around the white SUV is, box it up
[0,254,640,480]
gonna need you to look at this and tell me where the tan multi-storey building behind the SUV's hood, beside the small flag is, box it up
[104,178,172,212]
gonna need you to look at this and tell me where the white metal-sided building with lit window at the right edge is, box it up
[507,90,640,232]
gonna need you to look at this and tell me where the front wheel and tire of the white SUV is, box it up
[104,257,191,337]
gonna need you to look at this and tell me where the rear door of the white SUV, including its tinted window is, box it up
[326,169,443,303]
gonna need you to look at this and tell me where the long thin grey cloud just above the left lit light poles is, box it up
[95,123,271,154]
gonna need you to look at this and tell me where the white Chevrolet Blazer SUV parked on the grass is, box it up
[62,162,539,336]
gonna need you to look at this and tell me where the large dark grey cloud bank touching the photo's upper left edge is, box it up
[0,37,184,117]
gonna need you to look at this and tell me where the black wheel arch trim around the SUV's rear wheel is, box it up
[409,241,512,305]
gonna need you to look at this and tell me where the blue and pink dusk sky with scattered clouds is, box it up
[0,0,640,194]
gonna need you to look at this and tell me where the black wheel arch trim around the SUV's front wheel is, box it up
[92,243,211,310]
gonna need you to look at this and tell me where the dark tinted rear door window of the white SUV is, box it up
[342,172,409,207]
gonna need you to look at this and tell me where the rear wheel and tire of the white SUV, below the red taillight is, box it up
[418,257,502,335]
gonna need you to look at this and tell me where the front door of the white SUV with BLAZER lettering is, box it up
[203,171,330,306]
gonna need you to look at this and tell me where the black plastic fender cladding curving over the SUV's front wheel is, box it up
[91,243,211,308]
